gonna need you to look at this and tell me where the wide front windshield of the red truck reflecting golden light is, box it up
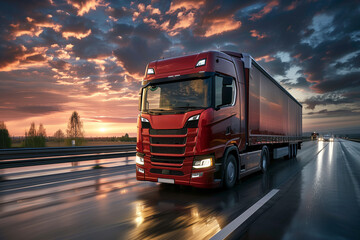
[141,78,211,112]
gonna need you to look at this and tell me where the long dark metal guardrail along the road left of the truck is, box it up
[0,144,136,169]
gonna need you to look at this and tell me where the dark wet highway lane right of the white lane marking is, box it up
[236,140,360,239]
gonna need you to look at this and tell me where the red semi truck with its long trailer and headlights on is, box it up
[136,51,302,188]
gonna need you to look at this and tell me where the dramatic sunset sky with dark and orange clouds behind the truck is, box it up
[0,0,360,136]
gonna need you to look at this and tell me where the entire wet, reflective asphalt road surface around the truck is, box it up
[0,140,360,239]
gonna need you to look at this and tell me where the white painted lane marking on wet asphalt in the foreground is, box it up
[210,189,279,240]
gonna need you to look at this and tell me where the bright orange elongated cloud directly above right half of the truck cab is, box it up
[203,17,241,37]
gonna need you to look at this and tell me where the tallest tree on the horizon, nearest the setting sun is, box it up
[66,111,84,146]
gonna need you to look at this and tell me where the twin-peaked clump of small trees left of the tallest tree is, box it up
[23,122,46,147]
